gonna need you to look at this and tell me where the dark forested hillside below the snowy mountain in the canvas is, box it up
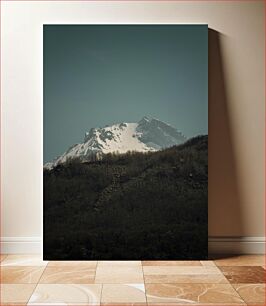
[44,136,208,260]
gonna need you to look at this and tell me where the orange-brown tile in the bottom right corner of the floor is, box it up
[233,284,266,304]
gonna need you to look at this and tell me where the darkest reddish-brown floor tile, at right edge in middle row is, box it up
[219,266,266,284]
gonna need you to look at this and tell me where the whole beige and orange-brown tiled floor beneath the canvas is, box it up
[1,255,266,306]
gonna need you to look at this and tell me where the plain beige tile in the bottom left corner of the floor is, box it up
[1,284,36,305]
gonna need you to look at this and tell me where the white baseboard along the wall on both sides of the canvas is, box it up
[0,237,265,254]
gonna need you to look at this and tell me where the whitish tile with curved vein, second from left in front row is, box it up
[28,284,102,305]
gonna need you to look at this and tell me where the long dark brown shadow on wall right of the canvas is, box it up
[208,29,243,241]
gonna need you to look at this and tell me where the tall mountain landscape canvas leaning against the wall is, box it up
[43,25,208,260]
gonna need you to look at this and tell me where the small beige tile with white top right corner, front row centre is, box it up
[101,284,146,305]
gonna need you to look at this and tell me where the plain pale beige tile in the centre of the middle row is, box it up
[95,265,144,284]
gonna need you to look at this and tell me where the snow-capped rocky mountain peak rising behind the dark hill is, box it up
[44,116,186,169]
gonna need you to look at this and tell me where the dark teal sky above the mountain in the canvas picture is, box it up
[44,25,208,162]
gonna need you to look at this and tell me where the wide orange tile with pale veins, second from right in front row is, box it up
[146,284,244,305]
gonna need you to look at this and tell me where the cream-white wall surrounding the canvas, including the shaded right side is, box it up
[1,1,265,252]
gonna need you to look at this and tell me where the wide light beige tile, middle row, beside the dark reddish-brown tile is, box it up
[143,266,228,284]
